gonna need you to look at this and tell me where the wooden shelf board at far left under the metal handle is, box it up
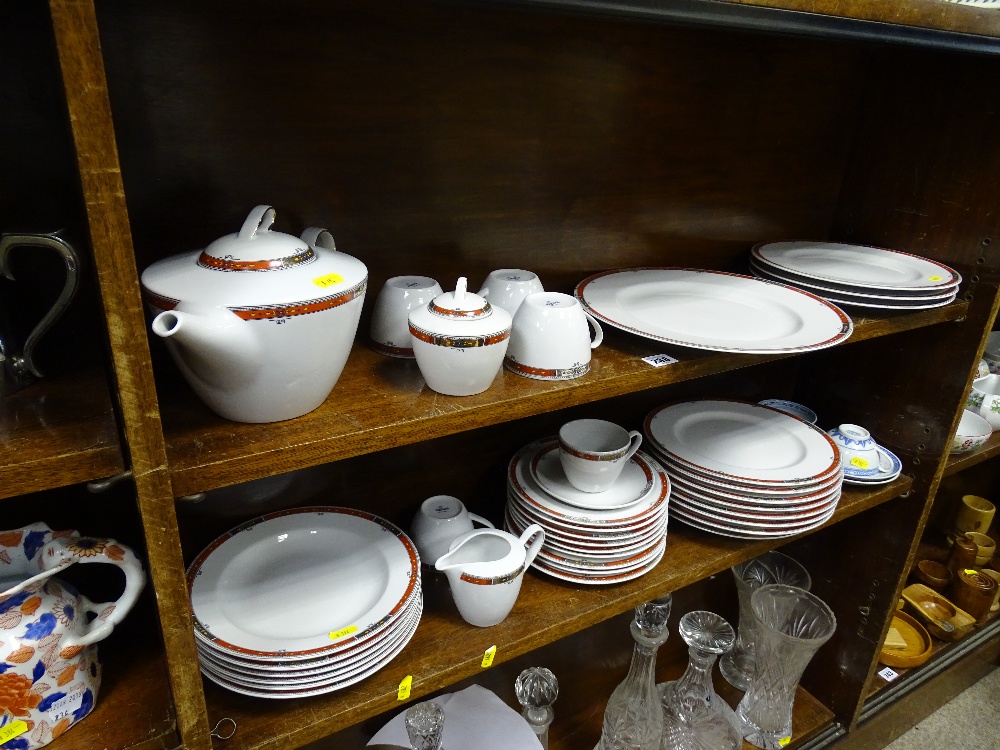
[0,370,124,498]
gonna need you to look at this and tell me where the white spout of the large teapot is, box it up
[152,302,264,387]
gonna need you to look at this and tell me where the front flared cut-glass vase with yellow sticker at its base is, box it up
[736,583,837,750]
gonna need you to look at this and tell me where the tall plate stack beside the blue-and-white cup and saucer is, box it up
[643,399,844,539]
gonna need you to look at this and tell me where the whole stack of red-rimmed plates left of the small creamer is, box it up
[187,507,423,698]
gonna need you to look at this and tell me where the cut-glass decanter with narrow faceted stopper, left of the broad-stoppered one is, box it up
[594,595,672,750]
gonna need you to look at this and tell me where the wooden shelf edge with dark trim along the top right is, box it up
[492,0,1000,54]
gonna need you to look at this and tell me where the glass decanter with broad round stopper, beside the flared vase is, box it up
[656,611,743,750]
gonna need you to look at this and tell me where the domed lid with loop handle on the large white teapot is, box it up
[198,206,316,271]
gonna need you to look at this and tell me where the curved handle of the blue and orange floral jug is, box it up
[41,536,146,649]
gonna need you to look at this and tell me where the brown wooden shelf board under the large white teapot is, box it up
[161,302,968,496]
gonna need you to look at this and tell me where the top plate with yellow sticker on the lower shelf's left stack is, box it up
[188,507,420,660]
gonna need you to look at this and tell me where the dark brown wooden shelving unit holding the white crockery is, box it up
[0,0,1000,750]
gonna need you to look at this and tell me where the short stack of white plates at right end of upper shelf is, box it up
[750,242,962,311]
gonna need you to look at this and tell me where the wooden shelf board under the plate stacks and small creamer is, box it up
[205,477,912,750]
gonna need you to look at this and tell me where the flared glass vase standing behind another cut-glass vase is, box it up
[719,550,812,692]
